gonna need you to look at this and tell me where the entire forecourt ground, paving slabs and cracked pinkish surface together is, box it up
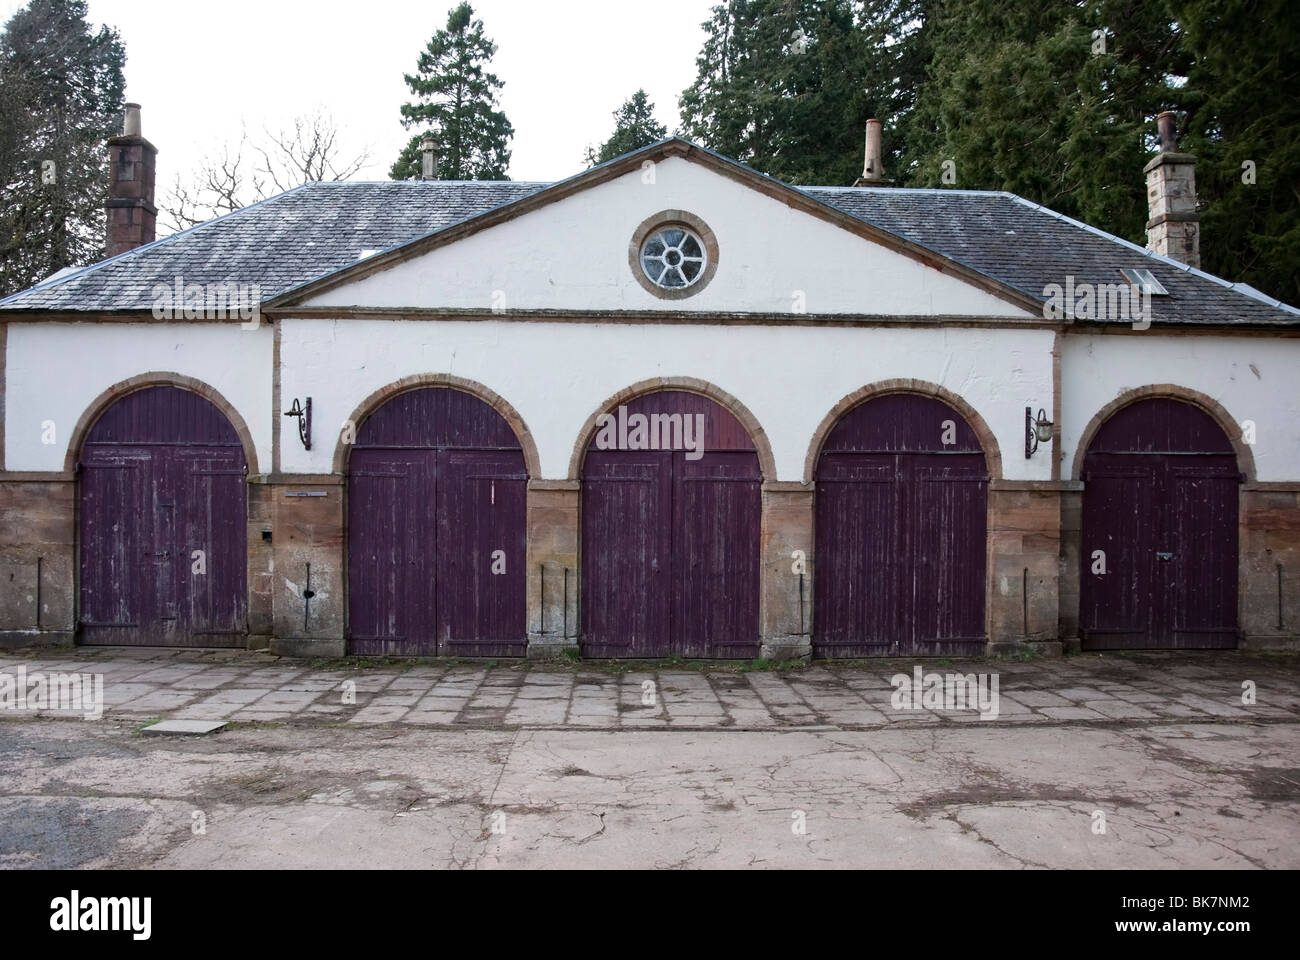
[0,649,1300,869]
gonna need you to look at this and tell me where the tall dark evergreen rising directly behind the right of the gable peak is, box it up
[680,0,868,183]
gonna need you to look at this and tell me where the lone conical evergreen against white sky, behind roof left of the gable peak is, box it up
[389,3,515,180]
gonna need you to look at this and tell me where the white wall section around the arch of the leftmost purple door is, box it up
[4,323,273,472]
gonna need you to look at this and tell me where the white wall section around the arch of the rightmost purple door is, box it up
[1061,330,1300,480]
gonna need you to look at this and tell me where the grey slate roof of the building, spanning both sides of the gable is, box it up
[0,138,1300,327]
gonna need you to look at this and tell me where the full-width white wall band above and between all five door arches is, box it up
[5,320,1300,481]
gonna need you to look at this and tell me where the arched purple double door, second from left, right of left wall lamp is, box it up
[347,388,528,657]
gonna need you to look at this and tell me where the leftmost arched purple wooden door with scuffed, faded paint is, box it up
[78,386,248,647]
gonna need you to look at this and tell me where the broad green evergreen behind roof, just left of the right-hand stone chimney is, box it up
[907,0,1177,242]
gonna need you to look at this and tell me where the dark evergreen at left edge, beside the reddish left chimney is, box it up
[0,0,126,295]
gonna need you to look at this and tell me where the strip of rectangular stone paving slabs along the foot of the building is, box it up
[0,648,1300,730]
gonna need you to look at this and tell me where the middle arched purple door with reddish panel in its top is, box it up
[582,390,763,658]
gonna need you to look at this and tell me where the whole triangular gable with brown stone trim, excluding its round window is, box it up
[265,138,1041,320]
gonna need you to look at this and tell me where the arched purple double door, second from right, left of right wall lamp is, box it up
[813,394,988,657]
